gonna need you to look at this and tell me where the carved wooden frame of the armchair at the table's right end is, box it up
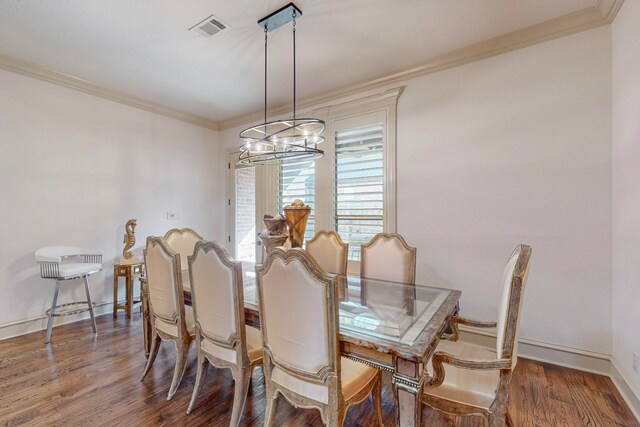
[423,244,531,427]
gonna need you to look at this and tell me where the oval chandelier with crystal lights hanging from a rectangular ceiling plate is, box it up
[239,3,325,165]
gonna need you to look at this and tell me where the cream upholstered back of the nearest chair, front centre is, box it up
[257,248,340,404]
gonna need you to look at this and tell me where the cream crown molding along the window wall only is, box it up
[218,0,624,130]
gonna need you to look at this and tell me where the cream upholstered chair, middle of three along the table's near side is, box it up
[187,240,262,427]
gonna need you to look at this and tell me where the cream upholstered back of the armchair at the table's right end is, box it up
[496,245,531,369]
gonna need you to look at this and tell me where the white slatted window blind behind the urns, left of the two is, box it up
[278,160,316,242]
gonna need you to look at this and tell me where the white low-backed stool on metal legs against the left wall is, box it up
[35,246,102,344]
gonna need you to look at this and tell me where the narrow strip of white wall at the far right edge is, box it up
[612,0,640,398]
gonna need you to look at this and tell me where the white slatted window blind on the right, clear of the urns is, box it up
[334,123,384,261]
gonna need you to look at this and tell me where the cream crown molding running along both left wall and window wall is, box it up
[0,0,624,130]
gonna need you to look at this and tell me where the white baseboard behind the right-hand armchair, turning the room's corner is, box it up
[460,325,640,422]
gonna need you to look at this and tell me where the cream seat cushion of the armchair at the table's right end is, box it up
[424,341,500,409]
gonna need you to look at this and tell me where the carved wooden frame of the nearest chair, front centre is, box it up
[256,248,382,427]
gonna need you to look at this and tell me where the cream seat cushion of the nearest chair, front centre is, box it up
[272,357,378,404]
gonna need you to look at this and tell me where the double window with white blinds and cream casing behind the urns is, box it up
[264,88,402,268]
